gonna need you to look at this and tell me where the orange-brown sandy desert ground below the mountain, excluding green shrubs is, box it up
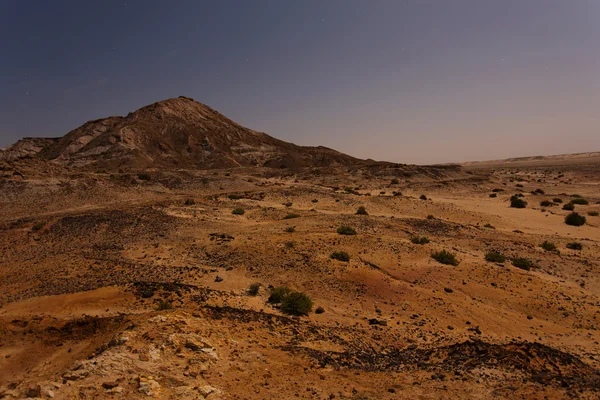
[0,164,600,399]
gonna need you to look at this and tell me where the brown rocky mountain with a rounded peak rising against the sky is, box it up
[0,97,376,170]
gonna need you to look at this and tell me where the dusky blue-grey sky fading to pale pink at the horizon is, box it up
[0,0,600,164]
